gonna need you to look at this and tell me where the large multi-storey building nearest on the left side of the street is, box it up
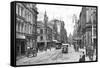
[16,3,38,56]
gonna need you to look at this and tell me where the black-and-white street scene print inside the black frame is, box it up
[15,2,97,65]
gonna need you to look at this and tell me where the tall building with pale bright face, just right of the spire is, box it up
[50,19,68,43]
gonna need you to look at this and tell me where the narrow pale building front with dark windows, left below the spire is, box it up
[37,21,46,50]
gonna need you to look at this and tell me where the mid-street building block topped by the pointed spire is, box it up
[37,12,53,50]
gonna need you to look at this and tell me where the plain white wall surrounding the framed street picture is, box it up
[0,0,100,68]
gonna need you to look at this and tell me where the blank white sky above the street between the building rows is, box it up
[37,4,82,36]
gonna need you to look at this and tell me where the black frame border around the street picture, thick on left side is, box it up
[10,1,98,67]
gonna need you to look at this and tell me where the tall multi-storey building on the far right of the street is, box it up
[78,7,97,56]
